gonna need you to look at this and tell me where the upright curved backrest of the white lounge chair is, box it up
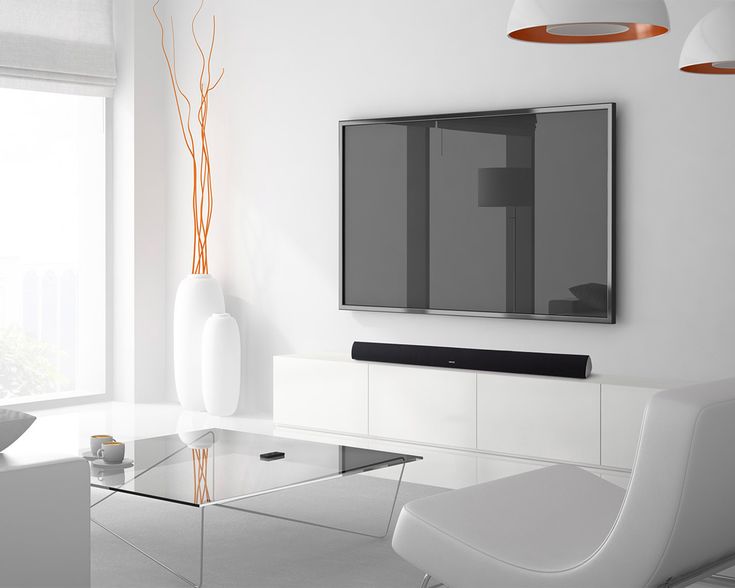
[598,379,735,586]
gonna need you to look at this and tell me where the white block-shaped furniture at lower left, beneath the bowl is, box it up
[0,451,90,588]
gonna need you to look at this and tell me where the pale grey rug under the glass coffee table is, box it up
[92,476,438,588]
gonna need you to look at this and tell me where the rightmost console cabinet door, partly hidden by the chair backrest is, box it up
[602,384,658,468]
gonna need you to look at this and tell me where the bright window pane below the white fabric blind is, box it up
[0,89,106,405]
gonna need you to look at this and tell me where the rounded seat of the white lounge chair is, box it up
[393,465,625,588]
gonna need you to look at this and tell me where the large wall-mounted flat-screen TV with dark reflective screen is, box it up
[339,103,615,323]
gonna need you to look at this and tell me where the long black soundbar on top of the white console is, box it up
[352,341,592,378]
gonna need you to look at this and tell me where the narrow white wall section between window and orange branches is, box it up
[108,0,167,401]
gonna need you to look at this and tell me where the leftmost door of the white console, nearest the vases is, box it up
[273,356,368,435]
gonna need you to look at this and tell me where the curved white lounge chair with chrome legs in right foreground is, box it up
[393,379,735,588]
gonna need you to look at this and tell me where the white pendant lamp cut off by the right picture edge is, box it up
[679,4,735,74]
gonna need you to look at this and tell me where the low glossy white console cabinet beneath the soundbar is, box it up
[273,354,669,470]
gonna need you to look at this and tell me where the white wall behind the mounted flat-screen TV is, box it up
[136,0,735,412]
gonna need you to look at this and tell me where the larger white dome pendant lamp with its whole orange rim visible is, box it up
[508,0,669,43]
